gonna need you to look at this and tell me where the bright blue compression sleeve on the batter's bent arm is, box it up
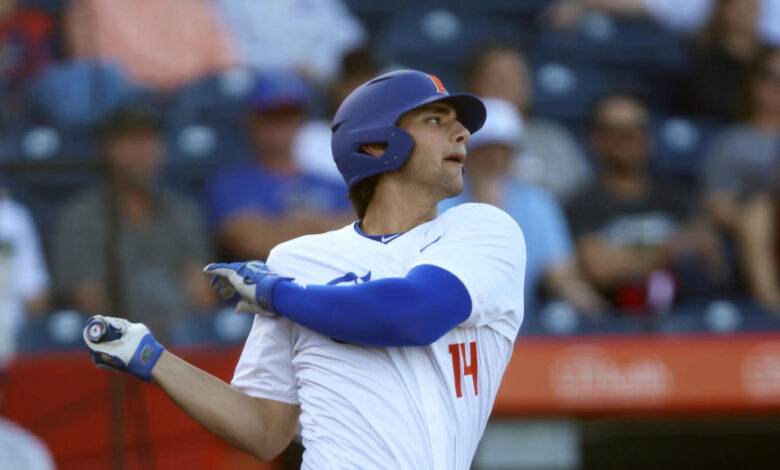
[273,265,471,346]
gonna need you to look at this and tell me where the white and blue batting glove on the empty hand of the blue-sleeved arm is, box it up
[203,261,293,314]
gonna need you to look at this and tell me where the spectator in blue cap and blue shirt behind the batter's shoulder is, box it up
[206,72,354,260]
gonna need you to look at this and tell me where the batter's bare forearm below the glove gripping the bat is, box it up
[152,350,298,460]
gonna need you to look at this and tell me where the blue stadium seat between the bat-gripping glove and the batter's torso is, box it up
[169,307,254,346]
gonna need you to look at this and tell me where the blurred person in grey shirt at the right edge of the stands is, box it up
[703,49,780,236]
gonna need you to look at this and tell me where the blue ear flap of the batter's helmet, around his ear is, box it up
[333,126,414,188]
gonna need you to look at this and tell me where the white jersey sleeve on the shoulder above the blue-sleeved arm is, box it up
[410,204,526,341]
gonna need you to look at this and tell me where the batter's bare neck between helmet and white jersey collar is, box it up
[360,186,438,235]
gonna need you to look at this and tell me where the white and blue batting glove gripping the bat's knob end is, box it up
[82,315,165,382]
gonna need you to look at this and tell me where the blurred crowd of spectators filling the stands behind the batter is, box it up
[0,0,780,468]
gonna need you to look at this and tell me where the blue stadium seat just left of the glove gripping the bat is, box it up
[16,310,85,352]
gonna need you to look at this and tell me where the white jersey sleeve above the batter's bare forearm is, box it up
[231,253,299,404]
